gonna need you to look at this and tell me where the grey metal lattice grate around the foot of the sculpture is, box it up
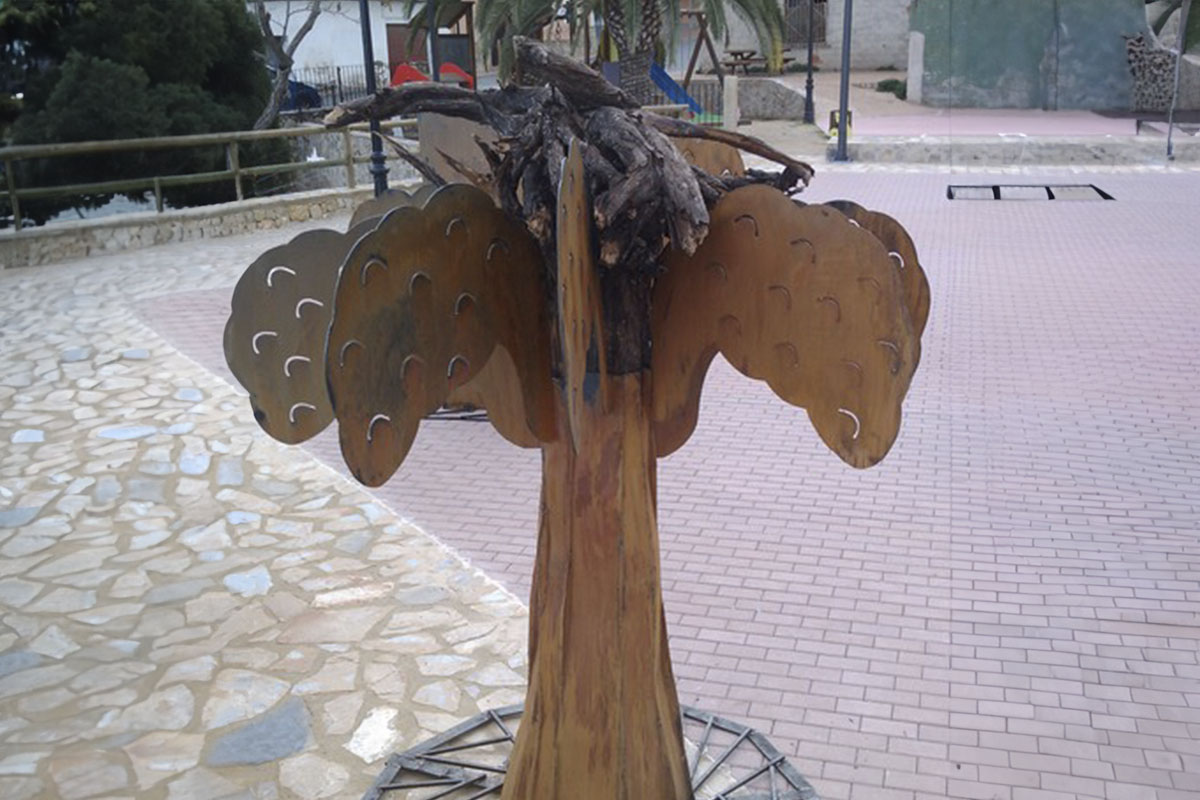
[362,705,817,800]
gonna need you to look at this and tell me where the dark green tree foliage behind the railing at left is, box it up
[0,0,281,222]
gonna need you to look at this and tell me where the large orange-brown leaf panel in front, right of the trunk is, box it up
[654,186,920,468]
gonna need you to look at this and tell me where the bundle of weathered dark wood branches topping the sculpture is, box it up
[325,38,812,316]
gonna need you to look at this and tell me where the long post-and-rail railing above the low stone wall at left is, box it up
[0,119,416,230]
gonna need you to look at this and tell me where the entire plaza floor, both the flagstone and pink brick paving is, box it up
[0,168,1200,800]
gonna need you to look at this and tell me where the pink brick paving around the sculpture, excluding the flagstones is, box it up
[144,165,1200,800]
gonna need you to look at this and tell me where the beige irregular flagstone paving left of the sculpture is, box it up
[0,230,526,800]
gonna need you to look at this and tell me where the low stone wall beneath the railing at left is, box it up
[0,186,371,269]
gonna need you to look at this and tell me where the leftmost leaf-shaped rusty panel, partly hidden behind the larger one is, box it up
[224,225,366,444]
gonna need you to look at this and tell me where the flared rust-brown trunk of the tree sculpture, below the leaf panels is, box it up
[502,373,691,800]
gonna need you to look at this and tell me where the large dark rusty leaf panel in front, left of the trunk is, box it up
[325,185,553,486]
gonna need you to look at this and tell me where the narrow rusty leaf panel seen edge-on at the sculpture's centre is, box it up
[554,139,606,450]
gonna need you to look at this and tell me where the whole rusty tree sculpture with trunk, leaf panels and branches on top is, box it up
[226,41,929,800]
